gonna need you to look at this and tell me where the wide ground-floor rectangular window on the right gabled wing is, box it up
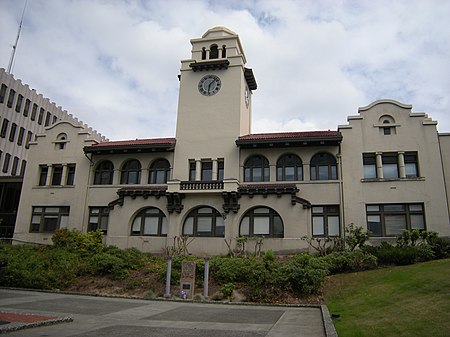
[366,204,425,236]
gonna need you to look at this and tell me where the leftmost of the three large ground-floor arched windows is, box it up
[131,207,167,236]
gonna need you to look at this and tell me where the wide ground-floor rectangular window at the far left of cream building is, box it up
[30,206,70,233]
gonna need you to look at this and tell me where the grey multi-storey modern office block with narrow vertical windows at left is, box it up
[0,68,104,237]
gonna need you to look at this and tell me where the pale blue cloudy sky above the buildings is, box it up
[0,0,450,140]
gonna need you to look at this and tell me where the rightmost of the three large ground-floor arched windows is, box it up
[239,207,284,238]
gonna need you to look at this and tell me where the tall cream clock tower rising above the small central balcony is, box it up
[173,27,257,181]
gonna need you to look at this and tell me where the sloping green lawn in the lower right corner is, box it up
[325,259,450,337]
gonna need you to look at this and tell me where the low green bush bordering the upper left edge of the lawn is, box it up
[323,250,377,274]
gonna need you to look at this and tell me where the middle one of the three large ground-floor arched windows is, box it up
[183,207,225,237]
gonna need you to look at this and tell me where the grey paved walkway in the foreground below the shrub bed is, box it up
[0,289,335,337]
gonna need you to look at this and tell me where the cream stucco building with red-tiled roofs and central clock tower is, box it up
[14,27,450,255]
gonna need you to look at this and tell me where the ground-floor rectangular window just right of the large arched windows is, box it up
[312,205,341,236]
